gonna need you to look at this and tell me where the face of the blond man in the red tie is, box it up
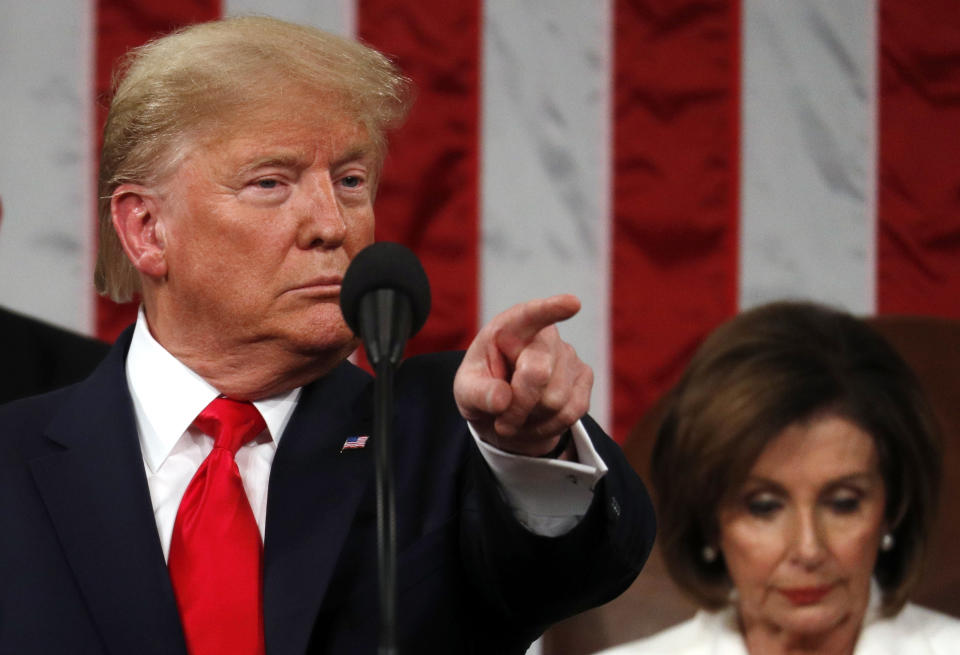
[151,93,379,353]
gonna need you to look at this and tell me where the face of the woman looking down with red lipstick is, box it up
[718,416,886,635]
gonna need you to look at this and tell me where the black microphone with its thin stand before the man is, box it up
[340,241,430,655]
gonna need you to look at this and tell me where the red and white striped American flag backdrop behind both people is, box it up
[0,0,960,452]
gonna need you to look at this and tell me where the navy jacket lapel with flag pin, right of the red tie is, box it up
[264,363,373,655]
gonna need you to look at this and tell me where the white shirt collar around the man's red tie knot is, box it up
[126,307,301,472]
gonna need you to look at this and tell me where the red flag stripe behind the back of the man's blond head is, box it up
[92,0,221,341]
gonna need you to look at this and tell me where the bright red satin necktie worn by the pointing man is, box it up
[168,398,265,655]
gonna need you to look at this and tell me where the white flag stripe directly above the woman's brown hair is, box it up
[740,0,876,313]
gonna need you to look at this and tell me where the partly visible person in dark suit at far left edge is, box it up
[0,197,110,404]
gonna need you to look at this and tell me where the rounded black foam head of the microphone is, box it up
[340,241,430,336]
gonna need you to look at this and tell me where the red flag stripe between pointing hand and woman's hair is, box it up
[611,0,740,441]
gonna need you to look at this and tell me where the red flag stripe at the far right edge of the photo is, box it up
[877,0,960,318]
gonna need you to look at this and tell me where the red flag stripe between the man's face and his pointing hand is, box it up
[357,0,481,354]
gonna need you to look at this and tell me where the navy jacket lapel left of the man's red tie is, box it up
[30,331,186,655]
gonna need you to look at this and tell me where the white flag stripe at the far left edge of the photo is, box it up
[0,0,95,333]
